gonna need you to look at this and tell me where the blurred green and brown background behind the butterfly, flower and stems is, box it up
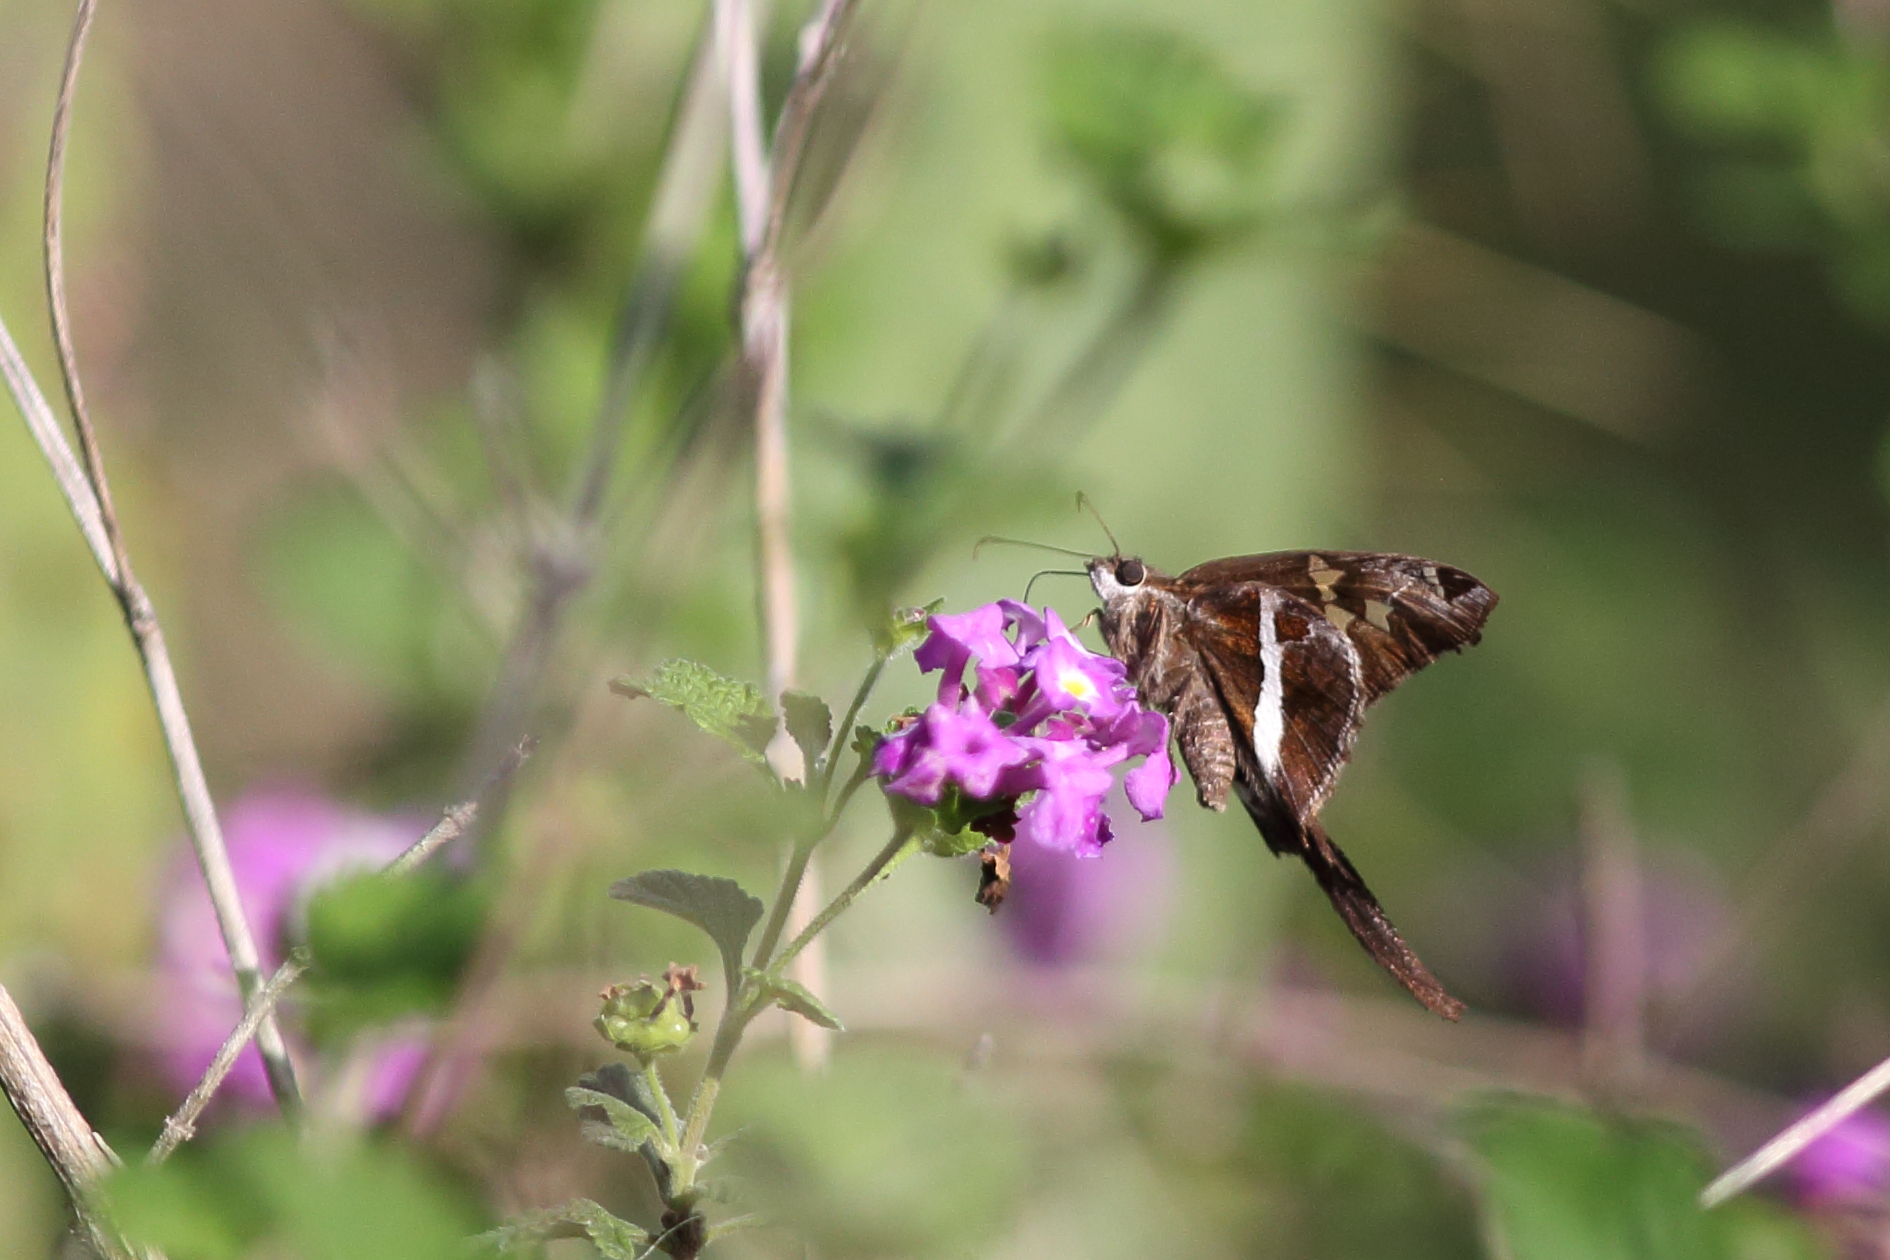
[0,0,1890,1260]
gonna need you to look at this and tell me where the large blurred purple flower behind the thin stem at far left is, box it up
[157,790,423,1118]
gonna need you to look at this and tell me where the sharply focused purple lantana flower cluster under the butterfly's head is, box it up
[873,599,1177,858]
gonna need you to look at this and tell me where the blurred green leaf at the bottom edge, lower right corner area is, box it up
[1465,1098,1735,1260]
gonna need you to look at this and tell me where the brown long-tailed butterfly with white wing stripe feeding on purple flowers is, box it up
[1089,552,1497,1020]
